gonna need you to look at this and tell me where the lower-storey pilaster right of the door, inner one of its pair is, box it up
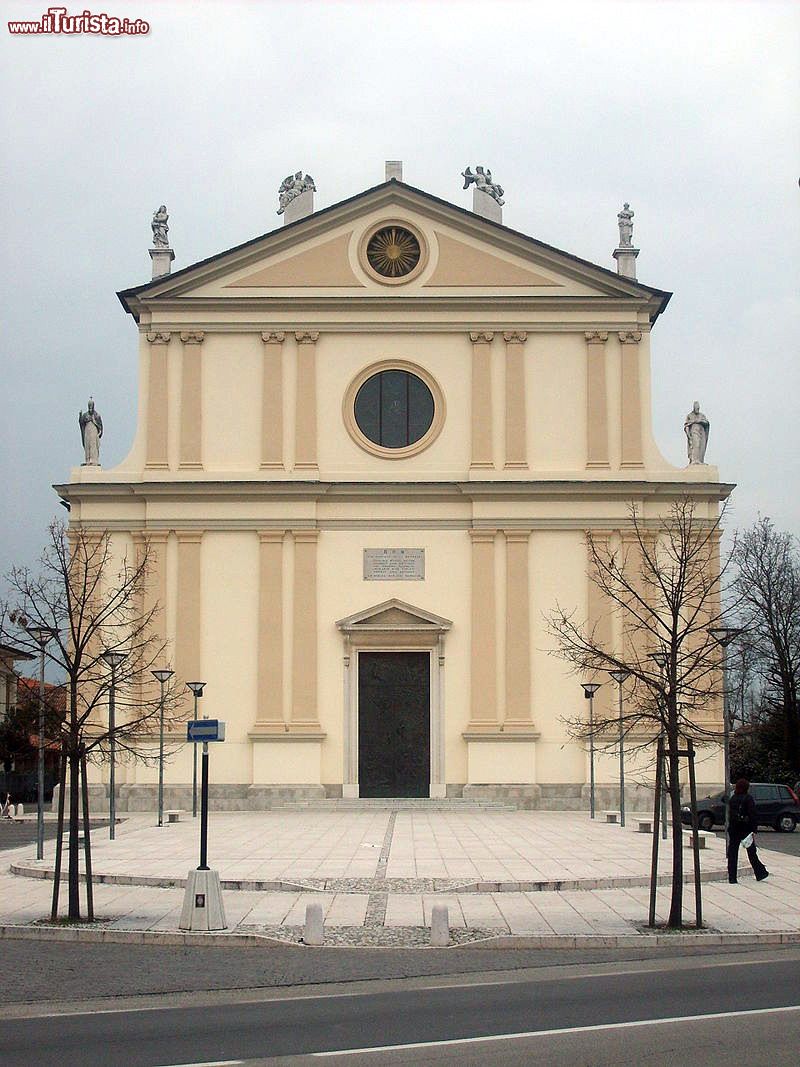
[467,529,498,733]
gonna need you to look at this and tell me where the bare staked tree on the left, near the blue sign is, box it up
[0,523,182,920]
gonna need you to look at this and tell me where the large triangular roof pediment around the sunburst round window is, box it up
[119,180,669,318]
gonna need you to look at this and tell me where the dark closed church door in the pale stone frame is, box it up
[358,652,431,797]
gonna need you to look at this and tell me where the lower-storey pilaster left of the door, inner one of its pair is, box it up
[291,529,320,733]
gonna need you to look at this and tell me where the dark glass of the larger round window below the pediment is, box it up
[354,370,433,448]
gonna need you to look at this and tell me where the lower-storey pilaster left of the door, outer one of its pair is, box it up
[254,529,285,732]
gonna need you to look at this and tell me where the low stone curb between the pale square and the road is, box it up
[0,925,800,952]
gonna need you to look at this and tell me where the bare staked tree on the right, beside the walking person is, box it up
[549,497,724,928]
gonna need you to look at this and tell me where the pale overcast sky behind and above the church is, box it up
[0,0,800,572]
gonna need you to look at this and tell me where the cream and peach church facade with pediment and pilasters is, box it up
[58,166,731,807]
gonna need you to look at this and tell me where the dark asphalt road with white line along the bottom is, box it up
[0,946,800,1067]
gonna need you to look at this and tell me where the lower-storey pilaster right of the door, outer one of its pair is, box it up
[503,529,533,730]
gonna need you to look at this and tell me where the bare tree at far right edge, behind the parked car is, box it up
[733,516,800,773]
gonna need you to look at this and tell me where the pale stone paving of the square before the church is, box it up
[0,809,800,944]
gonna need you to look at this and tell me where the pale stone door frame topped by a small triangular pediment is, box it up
[336,599,452,798]
